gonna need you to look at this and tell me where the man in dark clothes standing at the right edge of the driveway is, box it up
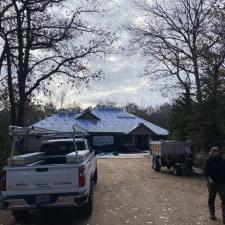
[204,147,225,224]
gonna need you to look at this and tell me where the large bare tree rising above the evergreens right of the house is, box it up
[129,0,219,103]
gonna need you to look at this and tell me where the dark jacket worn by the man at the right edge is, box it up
[204,157,225,185]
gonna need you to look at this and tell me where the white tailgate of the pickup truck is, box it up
[6,165,79,196]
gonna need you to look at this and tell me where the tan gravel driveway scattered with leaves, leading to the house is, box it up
[0,157,222,225]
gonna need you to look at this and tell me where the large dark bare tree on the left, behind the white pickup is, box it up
[0,0,113,126]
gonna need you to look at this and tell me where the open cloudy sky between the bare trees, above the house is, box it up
[46,0,170,107]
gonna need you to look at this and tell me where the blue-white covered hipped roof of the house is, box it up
[33,108,168,135]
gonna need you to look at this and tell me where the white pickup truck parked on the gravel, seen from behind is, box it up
[1,126,97,220]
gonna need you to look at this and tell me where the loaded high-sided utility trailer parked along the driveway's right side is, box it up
[150,141,193,176]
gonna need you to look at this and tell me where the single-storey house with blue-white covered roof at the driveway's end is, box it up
[29,107,168,151]
